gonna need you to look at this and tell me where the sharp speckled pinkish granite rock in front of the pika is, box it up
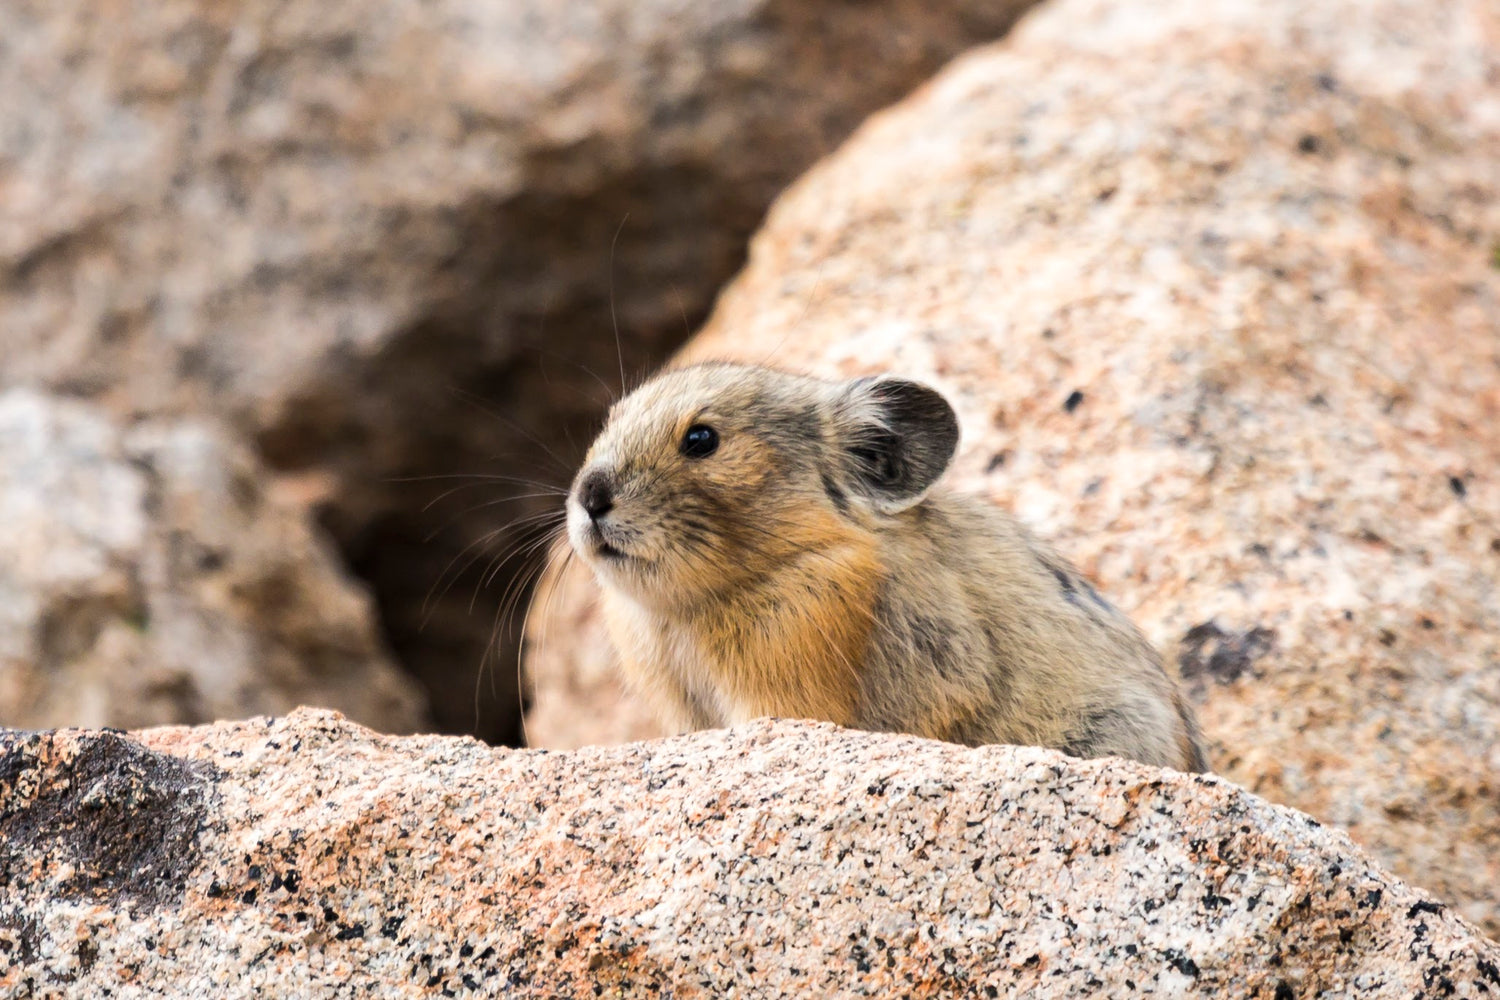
[0,711,1500,1000]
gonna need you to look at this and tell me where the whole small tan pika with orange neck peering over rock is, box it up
[566,363,1208,771]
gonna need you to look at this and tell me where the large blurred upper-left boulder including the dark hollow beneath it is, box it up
[0,0,1031,736]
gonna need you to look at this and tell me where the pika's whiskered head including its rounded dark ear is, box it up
[567,363,959,606]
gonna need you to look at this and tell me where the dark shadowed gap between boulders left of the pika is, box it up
[258,168,771,745]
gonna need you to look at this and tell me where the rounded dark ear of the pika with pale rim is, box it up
[834,376,959,514]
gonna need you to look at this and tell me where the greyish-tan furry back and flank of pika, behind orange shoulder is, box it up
[864,490,1208,771]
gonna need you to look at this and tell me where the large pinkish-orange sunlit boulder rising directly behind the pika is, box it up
[530,0,1500,934]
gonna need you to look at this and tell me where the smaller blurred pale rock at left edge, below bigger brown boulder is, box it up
[0,390,428,732]
